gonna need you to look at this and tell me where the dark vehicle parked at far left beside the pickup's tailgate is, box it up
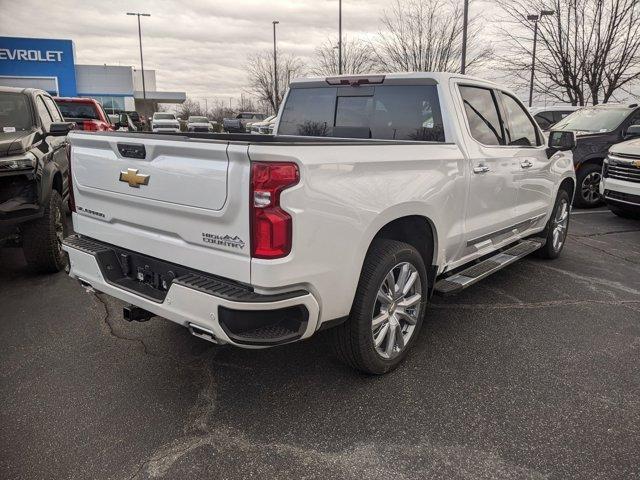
[0,87,74,272]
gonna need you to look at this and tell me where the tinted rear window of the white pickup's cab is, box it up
[278,85,444,142]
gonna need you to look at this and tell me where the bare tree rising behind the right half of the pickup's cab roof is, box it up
[375,0,491,72]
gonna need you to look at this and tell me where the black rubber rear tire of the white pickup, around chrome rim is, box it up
[333,239,429,375]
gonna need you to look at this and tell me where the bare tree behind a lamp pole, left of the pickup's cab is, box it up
[247,52,304,112]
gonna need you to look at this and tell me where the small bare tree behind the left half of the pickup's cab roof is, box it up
[311,37,378,76]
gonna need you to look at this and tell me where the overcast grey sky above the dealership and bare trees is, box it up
[0,0,500,102]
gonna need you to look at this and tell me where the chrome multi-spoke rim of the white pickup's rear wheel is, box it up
[371,262,422,359]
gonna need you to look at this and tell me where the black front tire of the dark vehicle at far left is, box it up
[22,190,68,273]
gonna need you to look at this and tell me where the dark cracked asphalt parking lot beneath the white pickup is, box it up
[0,210,640,479]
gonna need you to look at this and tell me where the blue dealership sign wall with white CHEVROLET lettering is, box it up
[0,37,78,97]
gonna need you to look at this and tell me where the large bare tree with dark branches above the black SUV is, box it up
[497,0,640,105]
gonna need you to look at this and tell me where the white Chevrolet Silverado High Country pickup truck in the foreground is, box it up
[64,73,575,374]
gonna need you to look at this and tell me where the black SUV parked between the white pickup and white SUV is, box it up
[553,104,640,208]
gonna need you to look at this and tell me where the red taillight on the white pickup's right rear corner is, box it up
[250,162,300,259]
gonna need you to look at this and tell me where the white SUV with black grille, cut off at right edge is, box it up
[600,125,640,218]
